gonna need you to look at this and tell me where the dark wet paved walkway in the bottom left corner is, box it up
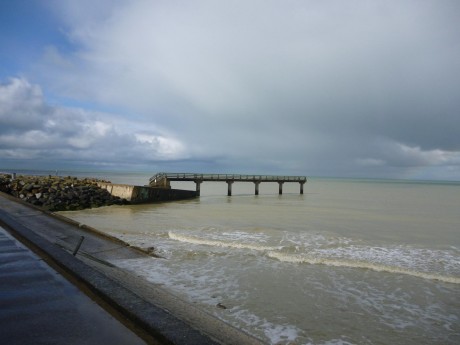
[0,228,145,345]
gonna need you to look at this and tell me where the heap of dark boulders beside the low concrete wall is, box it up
[0,174,129,211]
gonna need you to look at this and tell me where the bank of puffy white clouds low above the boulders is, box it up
[0,78,184,164]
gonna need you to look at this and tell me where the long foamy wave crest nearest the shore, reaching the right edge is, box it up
[267,251,460,284]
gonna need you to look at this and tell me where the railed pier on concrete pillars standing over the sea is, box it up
[149,172,307,196]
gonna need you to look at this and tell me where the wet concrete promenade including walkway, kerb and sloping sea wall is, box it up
[0,193,260,345]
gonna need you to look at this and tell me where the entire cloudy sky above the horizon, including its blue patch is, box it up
[0,0,460,180]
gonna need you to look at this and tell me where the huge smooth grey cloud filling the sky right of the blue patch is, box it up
[0,0,460,179]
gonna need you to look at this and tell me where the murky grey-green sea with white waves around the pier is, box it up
[54,174,460,345]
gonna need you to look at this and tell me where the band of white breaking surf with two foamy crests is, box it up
[168,231,460,284]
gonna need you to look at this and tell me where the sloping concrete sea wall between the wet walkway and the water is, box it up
[0,193,262,344]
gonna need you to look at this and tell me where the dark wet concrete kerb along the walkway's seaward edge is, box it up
[0,193,218,345]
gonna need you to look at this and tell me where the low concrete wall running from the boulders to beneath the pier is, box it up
[98,182,197,204]
